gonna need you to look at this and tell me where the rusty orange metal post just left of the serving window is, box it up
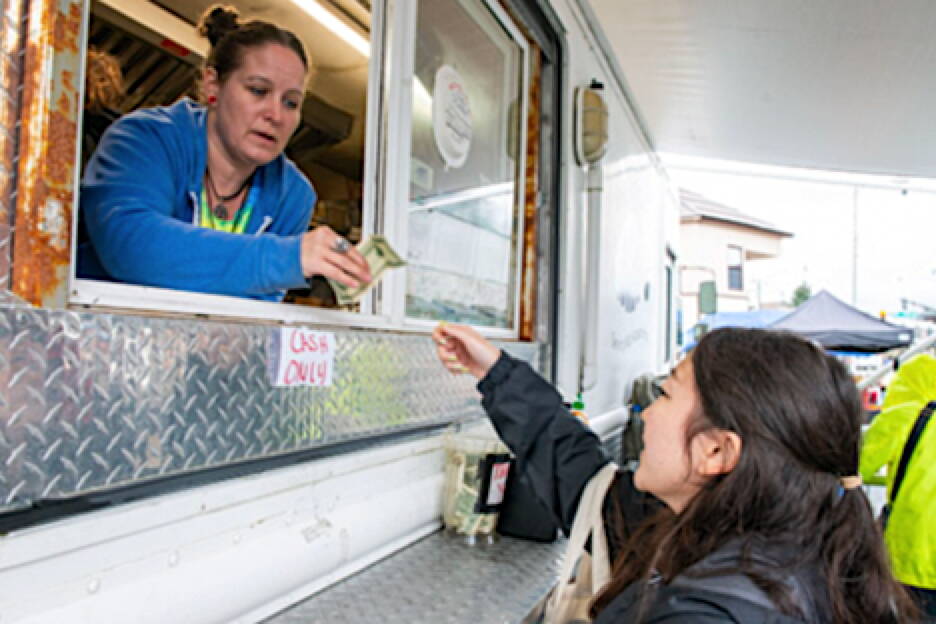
[11,0,82,307]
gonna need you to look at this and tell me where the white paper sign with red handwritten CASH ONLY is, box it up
[269,327,335,388]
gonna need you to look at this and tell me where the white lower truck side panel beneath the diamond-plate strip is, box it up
[0,437,443,624]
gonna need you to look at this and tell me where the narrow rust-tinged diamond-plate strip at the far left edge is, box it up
[0,0,25,297]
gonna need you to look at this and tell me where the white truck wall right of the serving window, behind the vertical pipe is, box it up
[554,0,678,415]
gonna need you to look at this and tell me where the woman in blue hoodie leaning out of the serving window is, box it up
[78,6,370,300]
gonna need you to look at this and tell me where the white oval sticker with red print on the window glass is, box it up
[432,65,471,169]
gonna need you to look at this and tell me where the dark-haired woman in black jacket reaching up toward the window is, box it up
[434,325,914,624]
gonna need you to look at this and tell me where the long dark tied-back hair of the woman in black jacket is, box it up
[592,328,915,624]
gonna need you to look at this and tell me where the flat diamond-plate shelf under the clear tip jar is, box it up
[266,533,566,624]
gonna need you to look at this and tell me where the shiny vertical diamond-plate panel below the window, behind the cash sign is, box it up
[0,307,504,512]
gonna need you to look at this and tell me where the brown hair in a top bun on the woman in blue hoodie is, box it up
[198,4,309,82]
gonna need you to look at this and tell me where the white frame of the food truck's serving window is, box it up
[65,0,530,340]
